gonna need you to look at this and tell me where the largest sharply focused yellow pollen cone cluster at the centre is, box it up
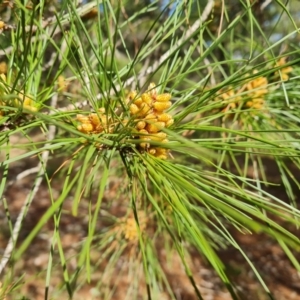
[128,83,174,159]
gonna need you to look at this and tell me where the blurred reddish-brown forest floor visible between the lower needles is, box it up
[0,137,300,300]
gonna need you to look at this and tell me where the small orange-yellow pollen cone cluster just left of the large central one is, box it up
[76,108,113,134]
